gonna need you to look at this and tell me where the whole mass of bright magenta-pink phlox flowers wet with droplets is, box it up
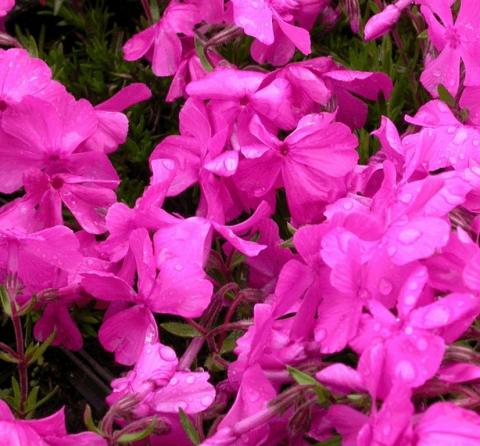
[0,0,480,446]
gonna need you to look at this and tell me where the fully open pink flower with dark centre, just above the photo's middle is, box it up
[234,114,358,223]
